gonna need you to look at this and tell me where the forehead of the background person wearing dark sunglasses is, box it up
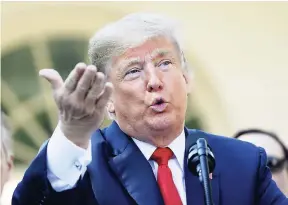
[239,133,284,158]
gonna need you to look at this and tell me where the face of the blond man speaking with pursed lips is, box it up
[110,37,188,143]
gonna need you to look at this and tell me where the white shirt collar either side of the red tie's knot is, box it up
[132,129,185,171]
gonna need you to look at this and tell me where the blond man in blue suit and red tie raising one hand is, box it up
[12,13,287,205]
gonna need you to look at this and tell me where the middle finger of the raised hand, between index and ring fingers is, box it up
[75,65,97,99]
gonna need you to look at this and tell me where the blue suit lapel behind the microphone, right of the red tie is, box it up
[184,128,219,205]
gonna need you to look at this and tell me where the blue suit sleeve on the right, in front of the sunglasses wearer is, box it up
[257,147,288,205]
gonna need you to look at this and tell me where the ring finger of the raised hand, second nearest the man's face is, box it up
[86,72,105,107]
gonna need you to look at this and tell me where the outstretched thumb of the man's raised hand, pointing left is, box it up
[39,68,63,91]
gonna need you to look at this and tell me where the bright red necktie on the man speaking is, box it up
[151,148,182,205]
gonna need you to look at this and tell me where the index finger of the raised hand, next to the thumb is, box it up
[65,63,87,93]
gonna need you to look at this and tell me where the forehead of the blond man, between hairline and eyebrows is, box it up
[117,37,177,62]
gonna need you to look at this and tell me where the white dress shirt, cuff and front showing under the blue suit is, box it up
[47,124,187,205]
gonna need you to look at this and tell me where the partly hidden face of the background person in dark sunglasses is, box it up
[239,133,288,195]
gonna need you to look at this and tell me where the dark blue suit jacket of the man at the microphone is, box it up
[12,122,288,205]
